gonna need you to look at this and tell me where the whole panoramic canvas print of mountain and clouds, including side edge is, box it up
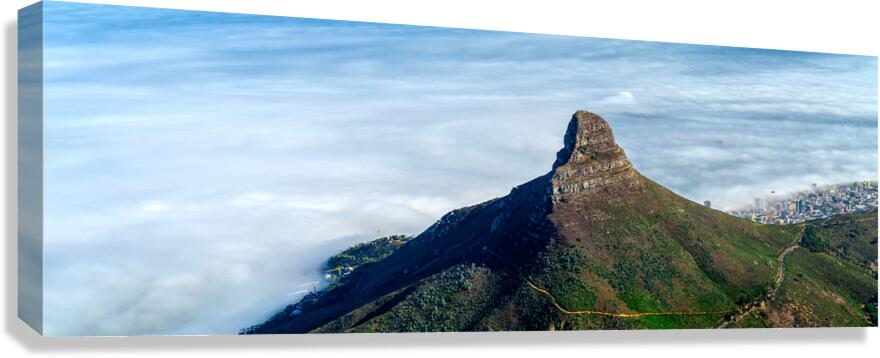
[19,1,878,336]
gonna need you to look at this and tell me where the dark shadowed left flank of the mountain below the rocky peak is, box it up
[244,171,554,333]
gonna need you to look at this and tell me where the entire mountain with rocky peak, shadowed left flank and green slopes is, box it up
[242,111,877,334]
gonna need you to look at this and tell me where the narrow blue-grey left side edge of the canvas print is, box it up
[18,2,43,334]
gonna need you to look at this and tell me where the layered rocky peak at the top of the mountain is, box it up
[551,110,638,201]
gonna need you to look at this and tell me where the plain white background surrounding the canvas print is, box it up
[0,0,880,358]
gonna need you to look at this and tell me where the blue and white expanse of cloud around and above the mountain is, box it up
[37,2,877,335]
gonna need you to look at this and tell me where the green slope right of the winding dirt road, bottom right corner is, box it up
[733,209,877,327]
